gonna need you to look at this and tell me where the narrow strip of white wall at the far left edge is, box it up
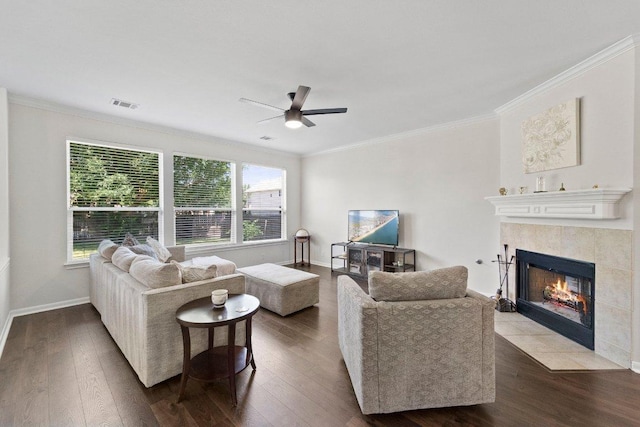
[0,88,11,346]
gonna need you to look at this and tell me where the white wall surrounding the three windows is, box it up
[9,102,300,310]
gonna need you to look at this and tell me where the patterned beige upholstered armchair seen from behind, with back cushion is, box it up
[338,266,495,414]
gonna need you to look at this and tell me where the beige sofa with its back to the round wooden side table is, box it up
[89,247,245,387]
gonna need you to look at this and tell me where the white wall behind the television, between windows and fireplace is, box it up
[301,119,499,293]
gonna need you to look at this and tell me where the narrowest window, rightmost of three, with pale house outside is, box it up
[242,164,286,242]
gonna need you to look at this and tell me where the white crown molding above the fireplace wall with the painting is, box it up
[494,33,640,116]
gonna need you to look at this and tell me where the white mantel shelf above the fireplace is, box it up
[485,188,631,219]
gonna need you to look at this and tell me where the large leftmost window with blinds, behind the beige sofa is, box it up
[67,141,162,262]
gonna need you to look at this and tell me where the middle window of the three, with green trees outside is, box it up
[173,155,235,245]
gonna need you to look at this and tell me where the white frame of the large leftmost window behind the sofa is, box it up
[65,138,164,266]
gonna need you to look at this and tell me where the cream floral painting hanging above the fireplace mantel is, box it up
[522,98,580,173]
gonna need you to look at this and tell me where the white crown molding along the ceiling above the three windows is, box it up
[8,93,300,158]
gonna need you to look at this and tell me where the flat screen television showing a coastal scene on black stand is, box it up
[349,210,400,246]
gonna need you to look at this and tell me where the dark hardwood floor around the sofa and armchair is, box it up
[0,267,640,427]
